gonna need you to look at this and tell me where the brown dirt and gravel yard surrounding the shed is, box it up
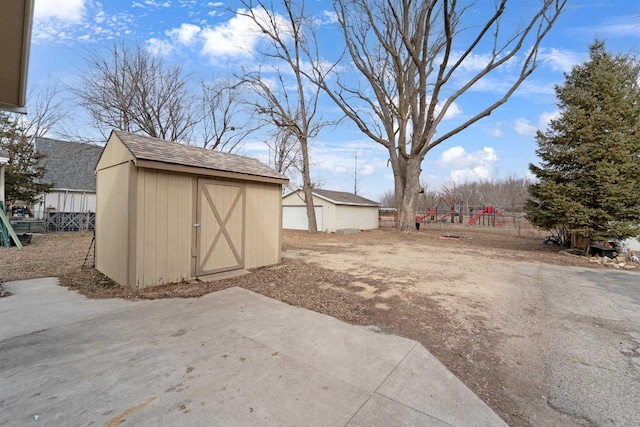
[0,224,636,426]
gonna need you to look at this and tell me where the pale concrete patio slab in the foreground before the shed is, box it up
[0,279,504,426]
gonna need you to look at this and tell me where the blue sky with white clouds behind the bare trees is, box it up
[29,0,640,200]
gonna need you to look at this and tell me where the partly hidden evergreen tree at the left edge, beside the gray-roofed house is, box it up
[0,113,53,208]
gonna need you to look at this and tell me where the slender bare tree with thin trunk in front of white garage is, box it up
[238,0,328,233]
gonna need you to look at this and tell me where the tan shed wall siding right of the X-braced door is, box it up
[245,182,282,268]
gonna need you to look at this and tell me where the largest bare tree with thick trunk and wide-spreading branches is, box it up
[314,0,567,232]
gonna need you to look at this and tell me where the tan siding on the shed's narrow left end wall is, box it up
[96,163,135,285]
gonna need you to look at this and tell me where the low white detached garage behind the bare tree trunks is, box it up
[282,189,379,232]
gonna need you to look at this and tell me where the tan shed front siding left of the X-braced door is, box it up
[136,168,195,288]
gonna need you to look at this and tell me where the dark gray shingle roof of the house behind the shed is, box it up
[35,138,103,192]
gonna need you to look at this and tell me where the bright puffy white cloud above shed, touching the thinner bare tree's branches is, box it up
[201,9,287,57]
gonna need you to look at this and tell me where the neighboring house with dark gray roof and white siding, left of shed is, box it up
[33,138,103,219]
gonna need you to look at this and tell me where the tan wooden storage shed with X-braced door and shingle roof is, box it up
[95,131,288,288]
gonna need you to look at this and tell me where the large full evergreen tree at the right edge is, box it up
[525,40,640,241]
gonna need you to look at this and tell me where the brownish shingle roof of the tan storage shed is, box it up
[113,130,288,181]
